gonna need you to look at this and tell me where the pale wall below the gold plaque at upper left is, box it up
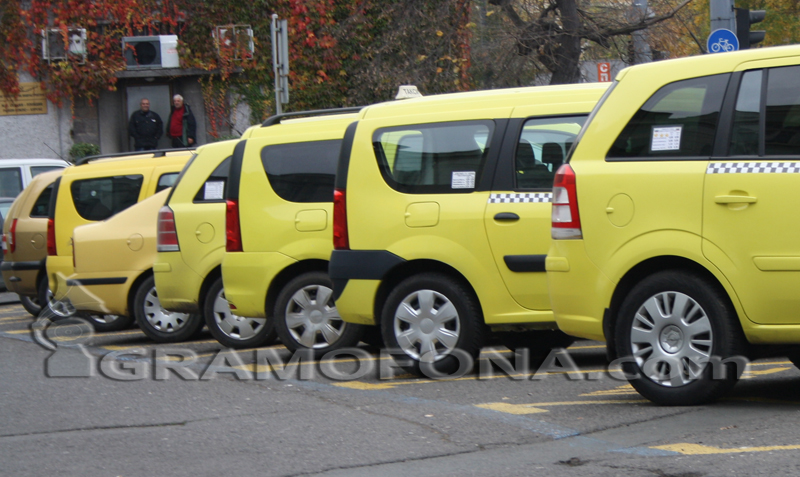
[0,74,72,159]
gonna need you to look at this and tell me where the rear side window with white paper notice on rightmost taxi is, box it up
[607,74,730,160]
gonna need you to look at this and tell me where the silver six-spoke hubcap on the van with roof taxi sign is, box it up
[394,290,461,362]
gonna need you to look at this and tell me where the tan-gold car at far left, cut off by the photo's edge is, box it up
[0,168,64,316]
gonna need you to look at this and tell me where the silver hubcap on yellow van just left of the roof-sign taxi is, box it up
[286,285,347,348]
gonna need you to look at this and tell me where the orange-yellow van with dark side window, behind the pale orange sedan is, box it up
[47,150,192,331]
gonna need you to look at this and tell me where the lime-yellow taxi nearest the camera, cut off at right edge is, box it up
[546,46,800,405]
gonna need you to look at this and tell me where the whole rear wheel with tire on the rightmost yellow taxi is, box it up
[615,271,747,406]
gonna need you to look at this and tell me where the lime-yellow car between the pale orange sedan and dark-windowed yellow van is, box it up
[155,137,268,347]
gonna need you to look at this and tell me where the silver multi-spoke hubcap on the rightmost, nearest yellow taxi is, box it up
[631,292,713,387]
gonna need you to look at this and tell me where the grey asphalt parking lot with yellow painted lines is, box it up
[0,304,800,477]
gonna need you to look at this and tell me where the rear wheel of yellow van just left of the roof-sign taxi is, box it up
[273,272,364,358]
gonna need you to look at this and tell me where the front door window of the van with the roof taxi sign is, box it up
[514,115,587,189]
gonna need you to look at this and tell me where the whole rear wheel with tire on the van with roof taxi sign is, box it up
[381,273,486,377]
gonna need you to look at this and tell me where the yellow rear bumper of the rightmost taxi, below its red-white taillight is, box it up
[545,240,615,341]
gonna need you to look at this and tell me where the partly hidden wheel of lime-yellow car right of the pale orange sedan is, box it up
[203,277,278,349]
